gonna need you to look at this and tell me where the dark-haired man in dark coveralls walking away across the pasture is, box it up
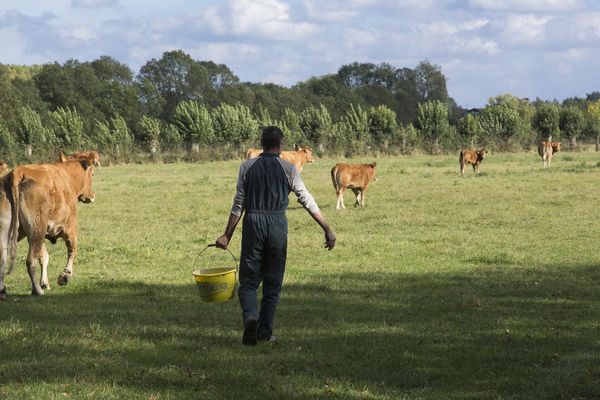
[216,126,335,346]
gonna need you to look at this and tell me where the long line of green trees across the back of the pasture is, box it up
[0,50,600,163]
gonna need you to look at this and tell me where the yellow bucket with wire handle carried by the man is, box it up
[192,244,237,303]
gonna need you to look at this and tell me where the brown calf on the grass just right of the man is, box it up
[331,163,377,210]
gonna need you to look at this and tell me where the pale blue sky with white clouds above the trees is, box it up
[0,0,600,108]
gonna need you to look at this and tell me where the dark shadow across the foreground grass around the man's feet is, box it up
[0,262,600,399]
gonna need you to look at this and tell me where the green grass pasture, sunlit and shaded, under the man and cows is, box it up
[0,153,600,400]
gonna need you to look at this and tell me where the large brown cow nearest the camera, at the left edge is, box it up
[0,155,95,300]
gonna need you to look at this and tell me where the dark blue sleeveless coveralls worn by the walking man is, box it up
[238,153,292,340]
